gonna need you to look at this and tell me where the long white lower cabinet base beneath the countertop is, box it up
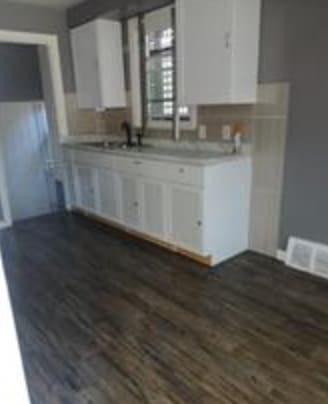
[65,149,252,265]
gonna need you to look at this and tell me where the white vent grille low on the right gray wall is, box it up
[286,237,328,279]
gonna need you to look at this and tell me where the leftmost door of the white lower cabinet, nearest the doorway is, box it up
[75,165,97,212]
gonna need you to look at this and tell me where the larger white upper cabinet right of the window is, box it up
[176,0,261,105]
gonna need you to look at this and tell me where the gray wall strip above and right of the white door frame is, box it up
[0,2,75,92]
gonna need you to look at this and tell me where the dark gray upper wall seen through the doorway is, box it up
[0,43,43,102]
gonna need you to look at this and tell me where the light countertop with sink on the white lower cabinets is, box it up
[63,143,248,166]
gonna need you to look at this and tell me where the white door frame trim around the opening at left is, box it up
[0,30,68,229]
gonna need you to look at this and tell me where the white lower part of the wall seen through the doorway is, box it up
[0,102,56,221]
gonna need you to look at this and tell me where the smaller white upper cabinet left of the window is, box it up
[71,19,126,108]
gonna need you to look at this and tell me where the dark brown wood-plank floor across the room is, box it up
[0,215,328,404]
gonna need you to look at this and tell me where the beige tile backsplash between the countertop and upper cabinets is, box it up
[66,83,289,147]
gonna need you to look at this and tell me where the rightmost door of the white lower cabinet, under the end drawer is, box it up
[169,185,203,253]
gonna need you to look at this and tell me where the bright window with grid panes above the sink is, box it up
[144,8,196,129]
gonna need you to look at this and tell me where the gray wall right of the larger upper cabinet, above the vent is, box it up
[260,0,328,248]
